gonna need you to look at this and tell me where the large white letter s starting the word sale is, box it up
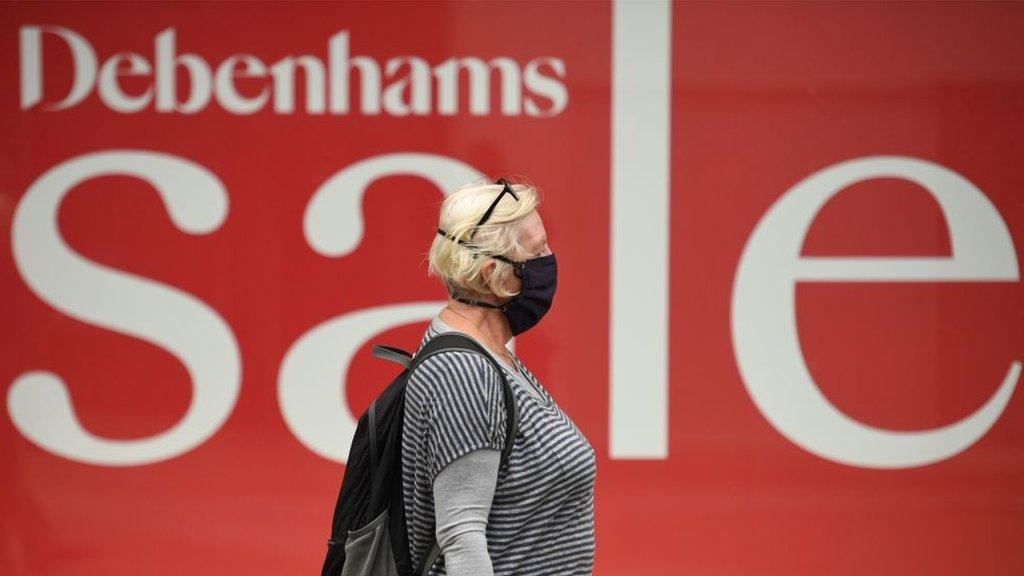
[7,150,241,466]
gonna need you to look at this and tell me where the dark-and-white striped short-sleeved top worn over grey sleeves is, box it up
[401,318,597,576]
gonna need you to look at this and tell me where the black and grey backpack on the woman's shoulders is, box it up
[321,332,518,576]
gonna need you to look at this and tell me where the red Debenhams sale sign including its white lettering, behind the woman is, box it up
[0,2,1024,576]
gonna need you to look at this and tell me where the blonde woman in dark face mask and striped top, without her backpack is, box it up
[402,179,596,576]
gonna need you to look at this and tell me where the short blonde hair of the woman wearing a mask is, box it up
[427,177,541,298]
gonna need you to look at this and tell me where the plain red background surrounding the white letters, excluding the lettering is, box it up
[0,3,1024,576]
